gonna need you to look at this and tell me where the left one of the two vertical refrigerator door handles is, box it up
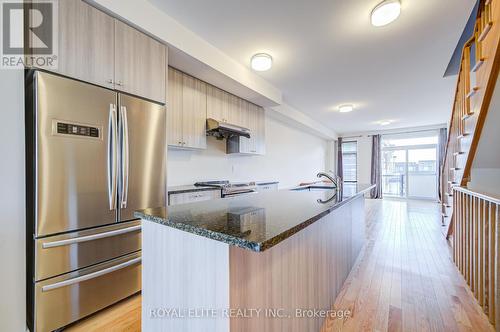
[108,104,118,210]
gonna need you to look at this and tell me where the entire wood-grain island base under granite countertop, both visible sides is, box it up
[142,196,365,332]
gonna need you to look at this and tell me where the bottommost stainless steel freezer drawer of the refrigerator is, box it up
[35,252,141,332]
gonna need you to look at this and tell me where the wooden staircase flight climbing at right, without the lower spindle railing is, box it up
[440,0,500,237]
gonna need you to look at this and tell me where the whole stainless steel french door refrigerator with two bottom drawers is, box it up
[26,71,166,332]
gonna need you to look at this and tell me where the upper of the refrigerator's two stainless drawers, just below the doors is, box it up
[35,220,141,281]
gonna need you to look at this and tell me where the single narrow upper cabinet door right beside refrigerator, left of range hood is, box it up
[167,68,183,147]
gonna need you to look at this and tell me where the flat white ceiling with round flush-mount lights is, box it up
[149,0,475,134]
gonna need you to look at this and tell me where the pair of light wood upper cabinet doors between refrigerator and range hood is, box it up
[167,68,207,149]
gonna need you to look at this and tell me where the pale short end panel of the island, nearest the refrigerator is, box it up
[142,221,229,332]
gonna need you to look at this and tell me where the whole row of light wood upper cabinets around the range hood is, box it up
[167,68,265,154]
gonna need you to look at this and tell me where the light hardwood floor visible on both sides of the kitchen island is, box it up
[66,199,493,332]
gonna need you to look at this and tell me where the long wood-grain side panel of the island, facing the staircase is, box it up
[229,197,365,332]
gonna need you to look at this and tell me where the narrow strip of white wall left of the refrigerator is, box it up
[0,69,26,332]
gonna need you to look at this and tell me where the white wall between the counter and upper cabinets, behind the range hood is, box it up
[167,112,327,187]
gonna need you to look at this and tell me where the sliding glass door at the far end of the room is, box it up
[382,132,438,199]
